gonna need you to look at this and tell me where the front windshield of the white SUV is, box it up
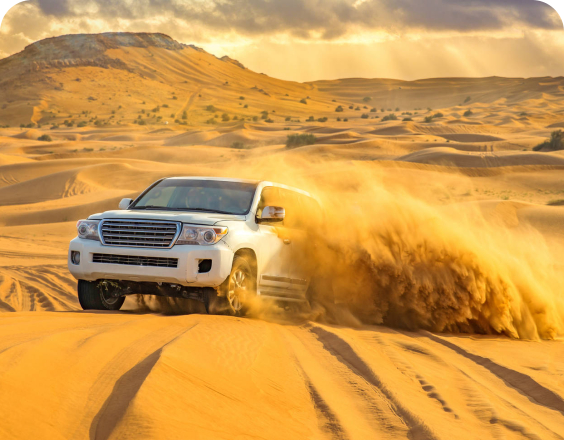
[129,179,257,215]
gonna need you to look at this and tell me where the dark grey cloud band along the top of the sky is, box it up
[29,0,562,40]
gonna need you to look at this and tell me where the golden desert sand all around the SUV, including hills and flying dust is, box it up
[0,34,564,440]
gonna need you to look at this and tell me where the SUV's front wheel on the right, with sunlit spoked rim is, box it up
[217,255,256,316]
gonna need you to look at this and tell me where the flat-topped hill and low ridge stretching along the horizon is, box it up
[0,33,564,125]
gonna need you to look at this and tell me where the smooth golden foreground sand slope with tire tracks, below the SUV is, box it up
[0,313,564,440]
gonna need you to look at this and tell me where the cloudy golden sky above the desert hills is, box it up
[0,0,564,81]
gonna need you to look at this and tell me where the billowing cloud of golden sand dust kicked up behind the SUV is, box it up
[230,157,564,339]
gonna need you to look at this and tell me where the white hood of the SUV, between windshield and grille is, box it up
[88,210,245,226]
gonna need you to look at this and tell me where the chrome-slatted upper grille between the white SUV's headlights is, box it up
[101,220,180,248]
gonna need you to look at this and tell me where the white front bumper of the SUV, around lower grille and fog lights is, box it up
[68,237,233,287]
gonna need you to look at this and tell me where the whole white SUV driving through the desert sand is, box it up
[68,177,320,315]
